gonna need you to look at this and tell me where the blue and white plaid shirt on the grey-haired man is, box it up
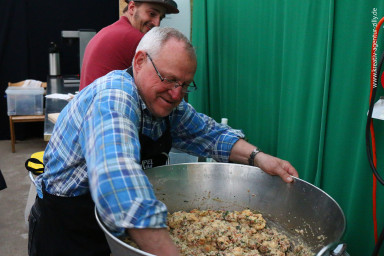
[36,70,244,235]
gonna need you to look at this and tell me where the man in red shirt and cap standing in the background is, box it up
[80,0,179,90]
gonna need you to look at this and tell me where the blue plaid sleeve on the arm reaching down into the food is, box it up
[86,88,167,235]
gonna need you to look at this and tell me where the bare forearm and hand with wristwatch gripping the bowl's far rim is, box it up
[229,139,299,182]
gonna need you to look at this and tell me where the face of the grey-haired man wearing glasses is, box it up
[134,38,196,117]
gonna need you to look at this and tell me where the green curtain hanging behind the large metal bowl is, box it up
[189,0,384,256]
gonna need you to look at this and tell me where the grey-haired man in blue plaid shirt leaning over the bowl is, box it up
[30,28,298,256]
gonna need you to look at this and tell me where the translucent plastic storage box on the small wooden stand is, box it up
[5,86,44,116]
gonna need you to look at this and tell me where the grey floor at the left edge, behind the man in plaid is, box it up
[0,138,46,256]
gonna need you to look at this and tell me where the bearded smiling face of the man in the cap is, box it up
[127,1,166,33]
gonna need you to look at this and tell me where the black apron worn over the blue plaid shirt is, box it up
[28,67,172,256]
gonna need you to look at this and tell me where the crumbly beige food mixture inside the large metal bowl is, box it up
[168,210,314,256]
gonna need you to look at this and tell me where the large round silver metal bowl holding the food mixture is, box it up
[96,163,346,256]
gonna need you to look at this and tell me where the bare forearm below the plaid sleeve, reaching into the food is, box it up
[128,228,180,256]
